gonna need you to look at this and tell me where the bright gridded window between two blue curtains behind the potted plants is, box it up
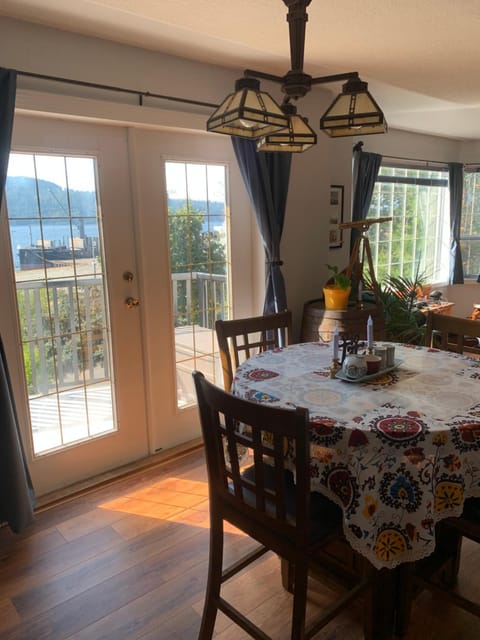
[367,165,450,282]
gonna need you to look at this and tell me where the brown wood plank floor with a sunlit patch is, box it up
[0,452,480,640]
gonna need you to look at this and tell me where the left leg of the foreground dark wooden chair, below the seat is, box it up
[198,516,223,640]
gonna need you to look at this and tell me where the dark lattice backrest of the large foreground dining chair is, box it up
[193,371,310,557]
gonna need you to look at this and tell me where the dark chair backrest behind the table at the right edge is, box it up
[425,312,480,354]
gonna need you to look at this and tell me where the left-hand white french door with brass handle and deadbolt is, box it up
[0,116,148,495]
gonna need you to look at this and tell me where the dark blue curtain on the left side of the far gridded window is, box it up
[350,142,382,253]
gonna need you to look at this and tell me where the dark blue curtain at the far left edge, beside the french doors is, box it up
[0,68,35,533]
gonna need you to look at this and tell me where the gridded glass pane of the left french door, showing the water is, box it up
[6,153,116,454]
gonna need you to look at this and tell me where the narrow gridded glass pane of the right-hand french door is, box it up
[165,162,230,407]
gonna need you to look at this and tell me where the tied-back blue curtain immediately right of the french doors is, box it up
[232,137,292,314]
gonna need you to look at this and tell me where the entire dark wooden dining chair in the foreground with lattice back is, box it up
[193,371,369,640]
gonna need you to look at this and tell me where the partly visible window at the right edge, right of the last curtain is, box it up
[460,169,480,278]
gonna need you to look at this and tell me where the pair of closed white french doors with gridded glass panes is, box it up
[0,115,264,495]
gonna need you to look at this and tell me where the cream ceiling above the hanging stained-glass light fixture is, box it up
[0,0,480,140]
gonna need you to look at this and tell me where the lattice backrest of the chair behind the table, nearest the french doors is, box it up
[215,310,292,391]
